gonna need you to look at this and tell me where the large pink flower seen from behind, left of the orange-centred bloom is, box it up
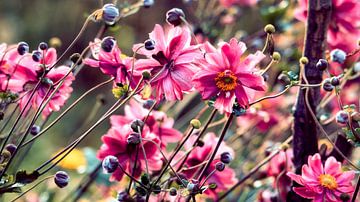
[133,25,200,101]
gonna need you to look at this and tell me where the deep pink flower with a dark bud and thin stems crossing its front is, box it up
[97,120,162,181]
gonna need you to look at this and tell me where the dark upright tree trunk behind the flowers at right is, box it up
[290,0,332,201]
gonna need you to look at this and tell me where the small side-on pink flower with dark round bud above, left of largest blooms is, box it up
[84,39,139,87]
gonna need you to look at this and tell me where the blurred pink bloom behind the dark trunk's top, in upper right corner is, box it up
[295,0,360,53]
